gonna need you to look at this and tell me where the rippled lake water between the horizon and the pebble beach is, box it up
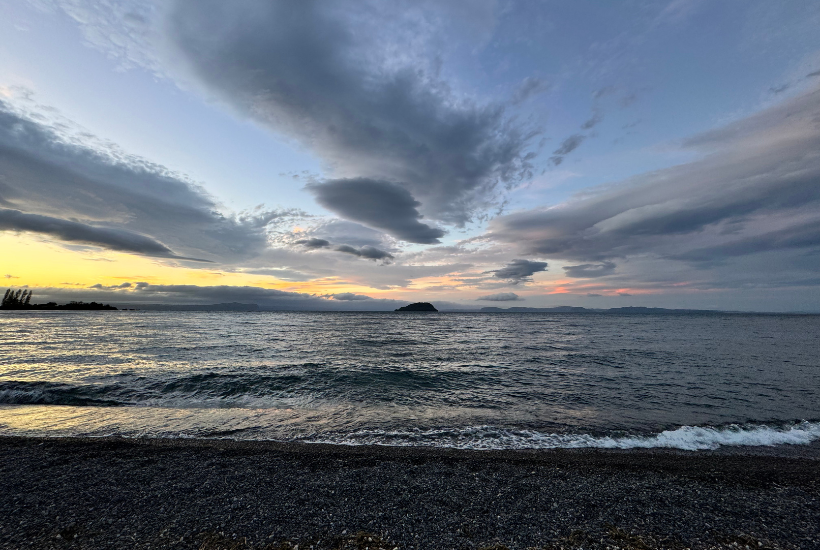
[0,311,820,449]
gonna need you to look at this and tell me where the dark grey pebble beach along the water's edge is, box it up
[0,437,820,550]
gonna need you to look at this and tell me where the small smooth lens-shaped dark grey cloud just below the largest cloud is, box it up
[307,178,444,244]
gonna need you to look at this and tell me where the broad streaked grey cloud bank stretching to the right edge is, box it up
[489,89,820,286]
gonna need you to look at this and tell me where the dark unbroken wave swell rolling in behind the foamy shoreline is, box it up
[0,363,506,408]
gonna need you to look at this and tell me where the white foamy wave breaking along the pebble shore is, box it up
[307,421,820,451]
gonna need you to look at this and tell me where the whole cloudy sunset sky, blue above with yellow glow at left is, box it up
[0,0,820,312]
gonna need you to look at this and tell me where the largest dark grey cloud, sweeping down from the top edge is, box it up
[166,0,535,232]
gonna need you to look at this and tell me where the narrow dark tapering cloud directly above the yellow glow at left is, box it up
[0,208,207,261]
